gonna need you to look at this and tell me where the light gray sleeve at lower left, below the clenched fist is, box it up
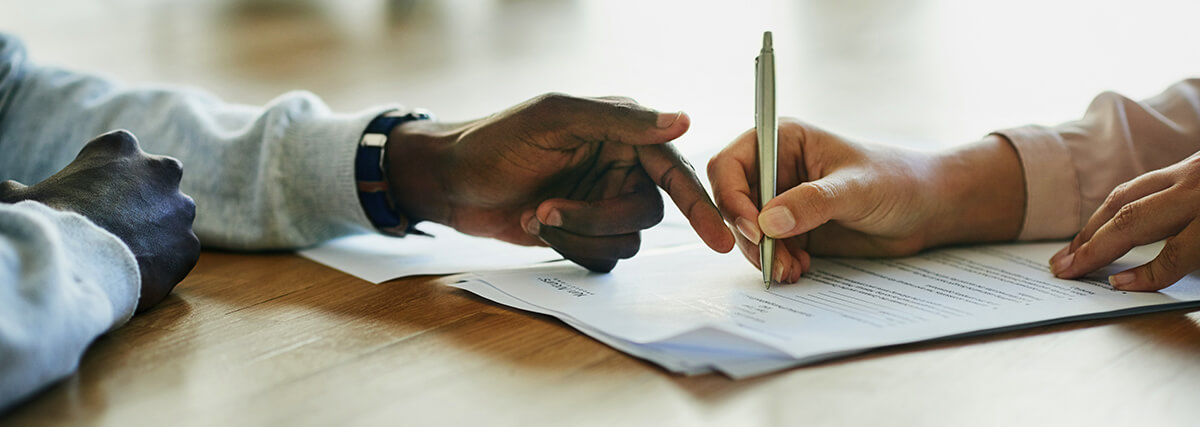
[0,202,139,411]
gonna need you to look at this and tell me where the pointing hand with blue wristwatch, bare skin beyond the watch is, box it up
[388,94,733,271]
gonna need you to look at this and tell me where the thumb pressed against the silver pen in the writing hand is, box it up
[758,175,856,239]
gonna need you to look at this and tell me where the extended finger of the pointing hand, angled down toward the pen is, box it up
[636,143,733,253]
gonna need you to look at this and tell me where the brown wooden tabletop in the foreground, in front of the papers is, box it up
[0,252,1200,426]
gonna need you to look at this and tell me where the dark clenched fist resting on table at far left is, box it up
[0,131,200,312]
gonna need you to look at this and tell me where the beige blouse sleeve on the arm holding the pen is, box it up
[996,79,1200,240]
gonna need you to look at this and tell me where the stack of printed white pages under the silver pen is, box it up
[454,242,1200,378]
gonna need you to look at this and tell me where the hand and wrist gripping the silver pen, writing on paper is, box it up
[708,119,1025,283]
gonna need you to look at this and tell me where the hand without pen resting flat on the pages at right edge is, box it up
[1050,154,1200,290]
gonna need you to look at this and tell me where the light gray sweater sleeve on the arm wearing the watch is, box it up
[0,35,389,249]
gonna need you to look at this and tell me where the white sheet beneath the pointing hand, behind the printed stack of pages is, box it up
[299,216,700,283]
